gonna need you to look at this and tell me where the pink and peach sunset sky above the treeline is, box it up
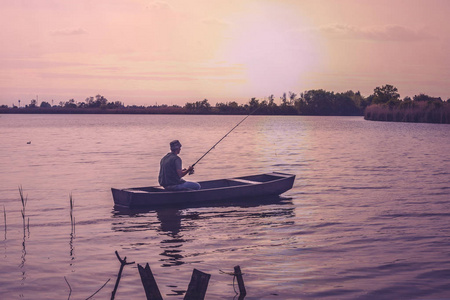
[0,0,450,106]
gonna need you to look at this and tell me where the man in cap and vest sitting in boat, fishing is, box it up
[158,140,200,191]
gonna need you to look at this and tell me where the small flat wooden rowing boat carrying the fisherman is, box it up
[111,172,295,208]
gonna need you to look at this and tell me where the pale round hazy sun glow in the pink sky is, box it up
[220,2,320,97]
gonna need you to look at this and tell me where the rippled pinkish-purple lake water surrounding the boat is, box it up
[0,115,450,299]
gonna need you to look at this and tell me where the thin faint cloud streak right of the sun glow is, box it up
[317,24,435,42]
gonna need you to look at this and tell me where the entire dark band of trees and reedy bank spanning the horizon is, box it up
[0,85,449,123]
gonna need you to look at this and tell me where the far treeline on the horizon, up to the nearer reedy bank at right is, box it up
[0,90,367,116]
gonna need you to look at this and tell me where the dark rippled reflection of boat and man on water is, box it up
[112,196,294,267]
